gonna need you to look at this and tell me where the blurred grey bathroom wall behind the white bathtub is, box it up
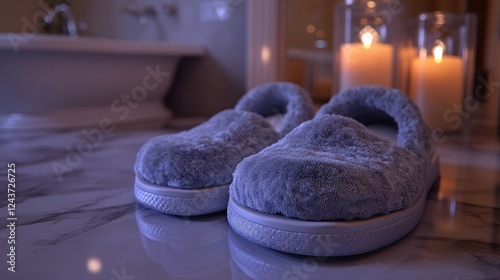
[0,0,247,116]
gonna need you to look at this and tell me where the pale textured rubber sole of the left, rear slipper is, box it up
[134,176,229,216]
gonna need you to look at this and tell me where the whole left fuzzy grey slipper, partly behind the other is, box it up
[134,83,314,216]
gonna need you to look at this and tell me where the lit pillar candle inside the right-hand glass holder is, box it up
[410,40,464,130]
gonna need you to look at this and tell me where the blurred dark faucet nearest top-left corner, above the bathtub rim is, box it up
[43,3,78,38]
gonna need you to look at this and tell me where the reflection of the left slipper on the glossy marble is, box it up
[135,206,229,279]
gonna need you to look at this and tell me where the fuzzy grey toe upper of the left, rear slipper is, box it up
[135,110,279,189]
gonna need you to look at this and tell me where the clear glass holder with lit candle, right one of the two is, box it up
[408,12,477,132]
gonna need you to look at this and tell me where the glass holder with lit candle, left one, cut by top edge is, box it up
[333,0,405,94]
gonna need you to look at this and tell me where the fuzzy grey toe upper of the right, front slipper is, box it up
[230,115,425,221]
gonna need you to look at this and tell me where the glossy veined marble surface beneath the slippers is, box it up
[0,121,500,280]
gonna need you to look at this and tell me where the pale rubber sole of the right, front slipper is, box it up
[227,155,439,257]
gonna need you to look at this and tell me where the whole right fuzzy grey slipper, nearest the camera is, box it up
[228,86,439,256]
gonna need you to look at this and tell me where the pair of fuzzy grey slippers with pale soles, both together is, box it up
[135,83,439,256]
